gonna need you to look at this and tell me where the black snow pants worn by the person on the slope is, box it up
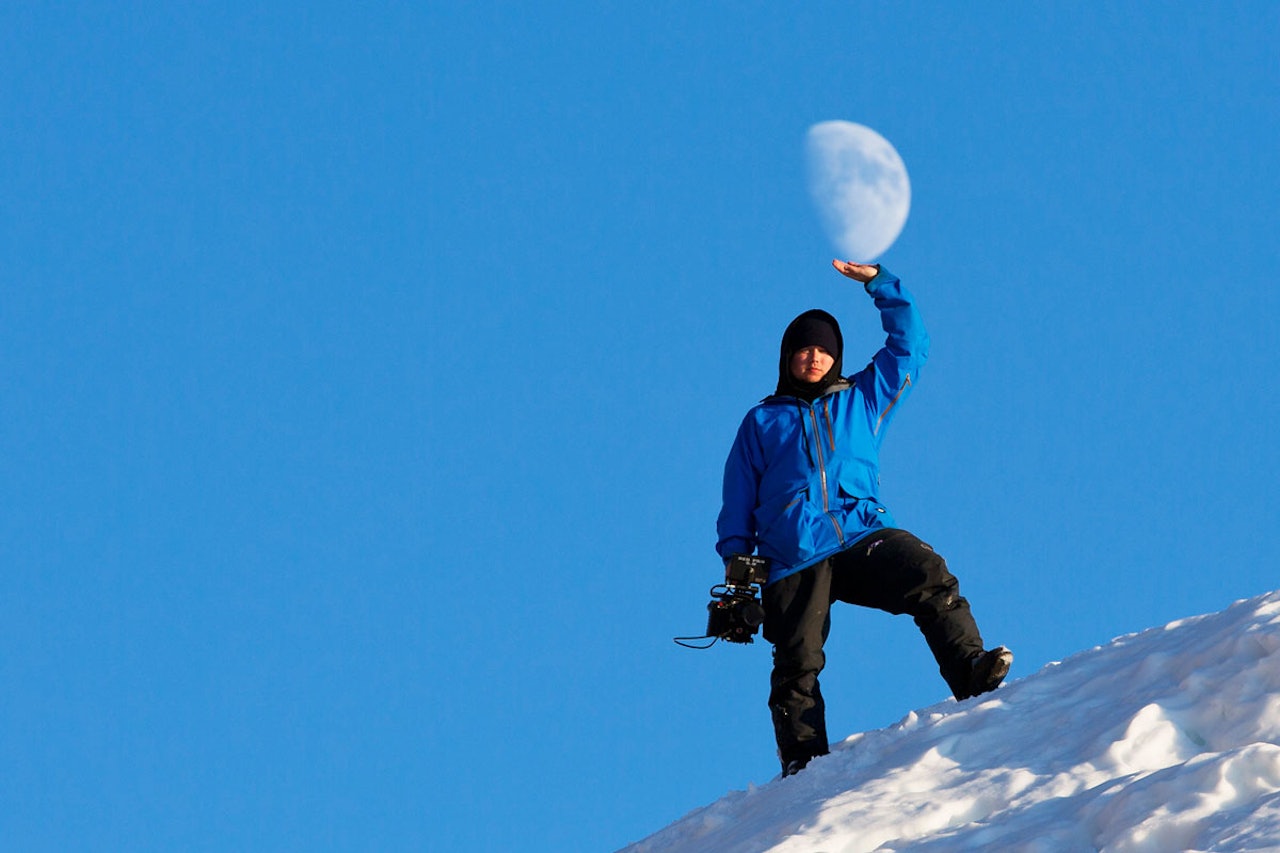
[764,530,983,766]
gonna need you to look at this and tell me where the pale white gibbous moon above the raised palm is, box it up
[805,120,911,261]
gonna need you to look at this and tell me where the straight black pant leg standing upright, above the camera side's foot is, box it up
[763,562,831,767]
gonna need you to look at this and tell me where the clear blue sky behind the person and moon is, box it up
[0,3,1280,850]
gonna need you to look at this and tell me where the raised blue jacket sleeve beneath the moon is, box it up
[858,268,929,437]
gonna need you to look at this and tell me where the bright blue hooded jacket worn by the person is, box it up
[716,268,929,584]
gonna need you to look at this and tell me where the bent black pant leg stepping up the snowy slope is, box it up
[831,529,983,697]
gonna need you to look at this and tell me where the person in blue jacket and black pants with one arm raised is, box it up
[717,260,1012,776]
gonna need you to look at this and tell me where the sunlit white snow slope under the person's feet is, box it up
[625,592,1280,853]
